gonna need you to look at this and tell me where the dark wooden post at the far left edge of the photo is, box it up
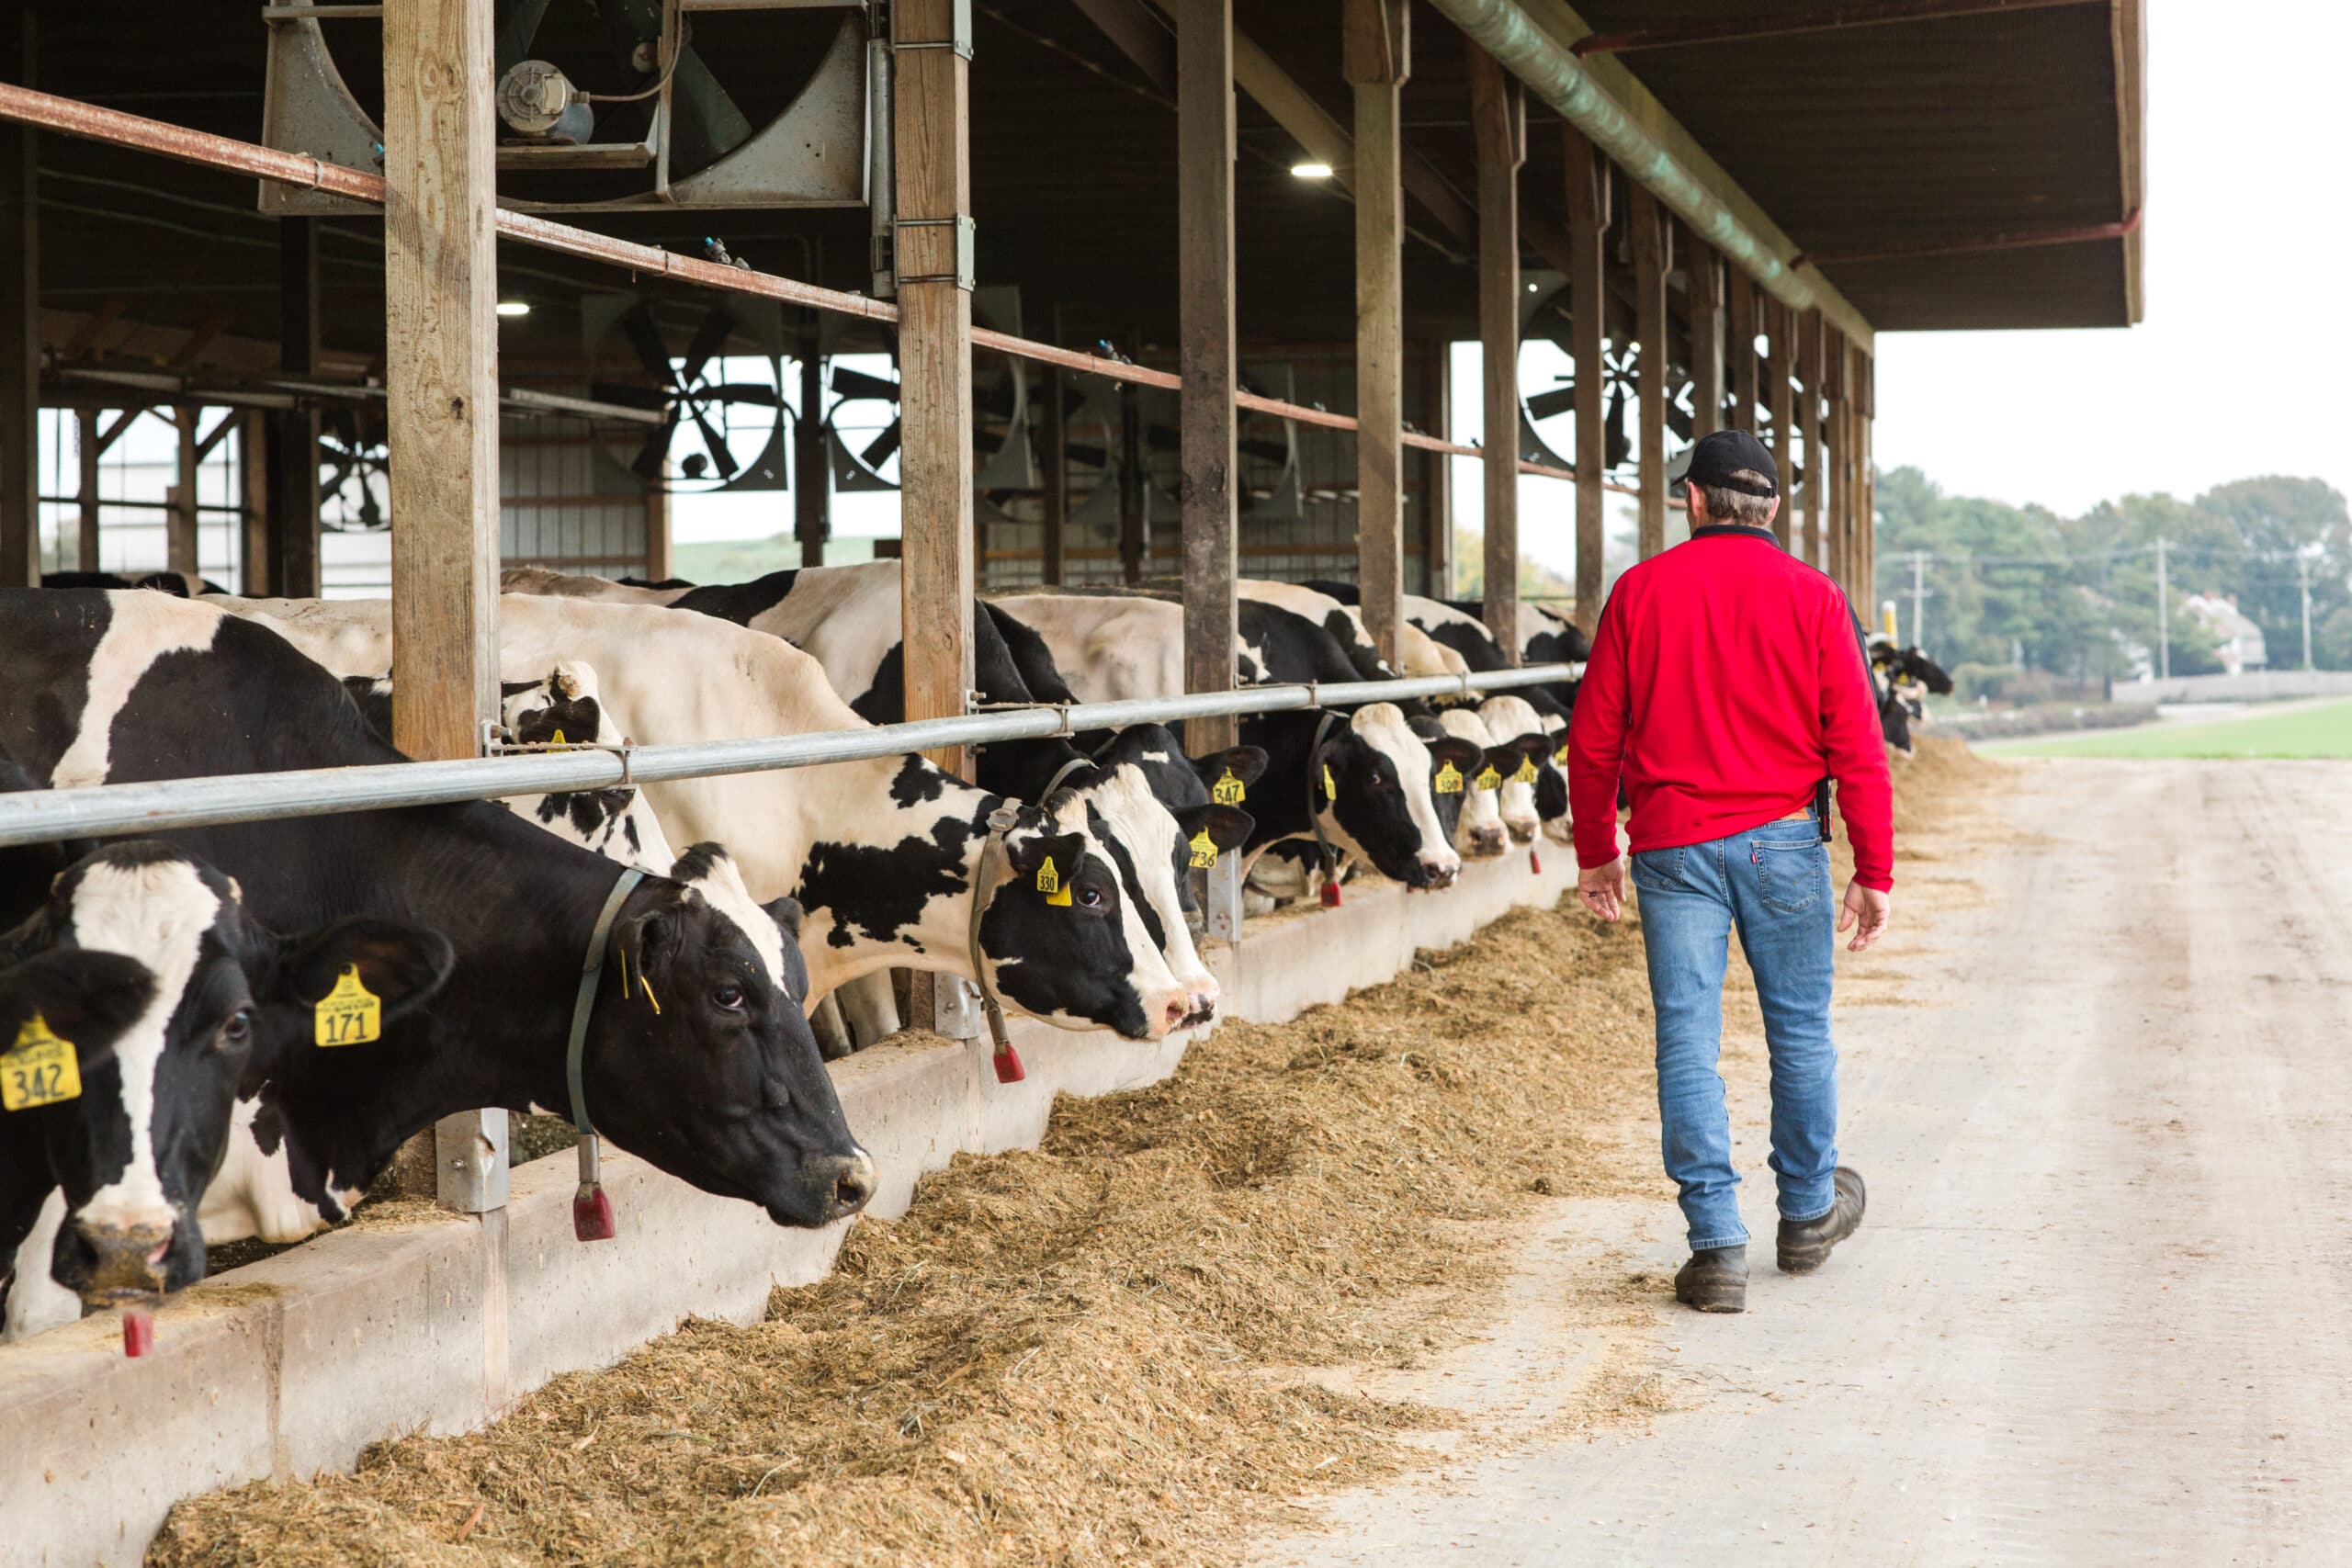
[0,5,40,588]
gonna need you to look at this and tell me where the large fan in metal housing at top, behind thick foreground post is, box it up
[261,0,889,214]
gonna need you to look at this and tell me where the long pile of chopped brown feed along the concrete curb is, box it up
[148,748,1983,1568]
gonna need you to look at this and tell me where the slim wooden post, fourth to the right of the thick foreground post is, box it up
[1463,42,1526,663]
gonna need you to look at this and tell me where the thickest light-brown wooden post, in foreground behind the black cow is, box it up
[383,0,505,1222]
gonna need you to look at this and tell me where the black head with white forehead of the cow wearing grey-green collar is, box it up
[583,844,875,1227]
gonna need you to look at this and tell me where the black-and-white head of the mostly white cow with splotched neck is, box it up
[974,792,1194,1039]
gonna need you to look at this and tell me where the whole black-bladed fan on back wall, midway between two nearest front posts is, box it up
[581,296,788,491]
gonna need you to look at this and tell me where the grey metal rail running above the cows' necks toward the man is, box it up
[0,665,1578,846]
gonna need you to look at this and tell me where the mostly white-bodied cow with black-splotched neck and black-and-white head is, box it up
[221,594,1193,1039]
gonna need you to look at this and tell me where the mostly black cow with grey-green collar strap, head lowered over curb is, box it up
[0,590,875,1269]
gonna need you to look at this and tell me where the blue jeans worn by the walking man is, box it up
[1633,816,1837,1253]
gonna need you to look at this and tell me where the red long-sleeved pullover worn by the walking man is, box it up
[1569,525,1894,891]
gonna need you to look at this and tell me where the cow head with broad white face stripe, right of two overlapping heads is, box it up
[1307,703,1482,888]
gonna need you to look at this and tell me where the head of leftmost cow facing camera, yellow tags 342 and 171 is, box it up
[0,840,449,1337]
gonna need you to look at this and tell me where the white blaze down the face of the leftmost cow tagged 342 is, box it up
[73,861,221,1224]
